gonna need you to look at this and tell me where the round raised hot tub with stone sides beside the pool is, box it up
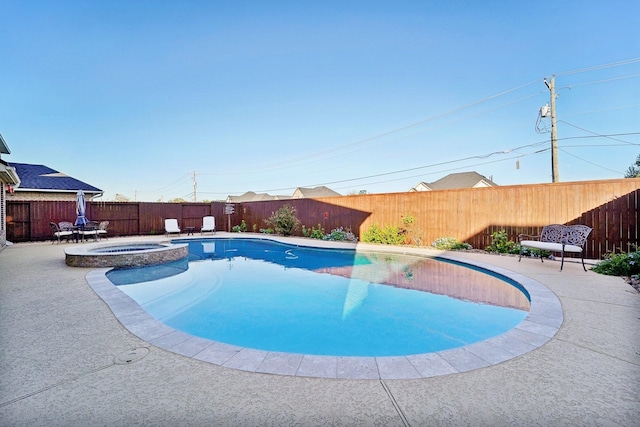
[64,242,189,268]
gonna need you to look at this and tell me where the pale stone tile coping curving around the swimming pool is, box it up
[86,237,563,380]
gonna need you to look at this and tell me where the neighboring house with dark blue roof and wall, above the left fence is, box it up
[9,163,103,201]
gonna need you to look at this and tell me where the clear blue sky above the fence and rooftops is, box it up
[0,0,640,201]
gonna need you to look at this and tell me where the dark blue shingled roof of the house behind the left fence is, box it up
[9,163,102,194]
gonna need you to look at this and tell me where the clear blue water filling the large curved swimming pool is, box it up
[108,239,529,356]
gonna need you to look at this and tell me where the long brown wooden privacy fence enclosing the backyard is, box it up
[7,178,640,259]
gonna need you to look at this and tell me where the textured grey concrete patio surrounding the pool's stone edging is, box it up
[0,239,640,426]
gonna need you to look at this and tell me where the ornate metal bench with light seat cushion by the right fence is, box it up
[518,224,592,271]
